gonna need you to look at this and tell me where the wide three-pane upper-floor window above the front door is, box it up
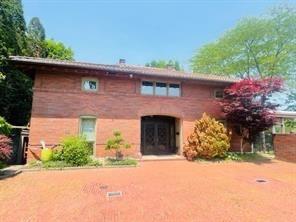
[141,81,181,97]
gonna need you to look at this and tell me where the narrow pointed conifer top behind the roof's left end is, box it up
[27,17,46,57]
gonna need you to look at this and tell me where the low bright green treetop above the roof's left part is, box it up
[45,39,74,60]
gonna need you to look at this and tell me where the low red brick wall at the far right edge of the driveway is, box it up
[273,134,296,162]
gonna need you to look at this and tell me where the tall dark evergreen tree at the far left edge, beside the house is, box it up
[0,0,32,125]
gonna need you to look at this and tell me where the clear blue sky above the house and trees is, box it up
[22,0,288,70]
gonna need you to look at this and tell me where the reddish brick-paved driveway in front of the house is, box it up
[0,161,296,222]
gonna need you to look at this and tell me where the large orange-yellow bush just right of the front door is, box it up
[183,113,230,160]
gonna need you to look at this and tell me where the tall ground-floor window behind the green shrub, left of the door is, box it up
[80,116,96,155]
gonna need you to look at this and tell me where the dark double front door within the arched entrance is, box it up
[141,116,175,155]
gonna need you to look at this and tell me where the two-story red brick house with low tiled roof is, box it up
[10,57,243,158]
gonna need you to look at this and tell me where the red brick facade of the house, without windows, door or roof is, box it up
[28,70,237,158]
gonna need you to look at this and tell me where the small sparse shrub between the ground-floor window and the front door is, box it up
[105,131,131,160]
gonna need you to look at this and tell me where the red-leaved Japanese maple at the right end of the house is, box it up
[220,77,283,151]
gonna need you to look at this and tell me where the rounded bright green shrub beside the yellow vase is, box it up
[54,136,90,166]
